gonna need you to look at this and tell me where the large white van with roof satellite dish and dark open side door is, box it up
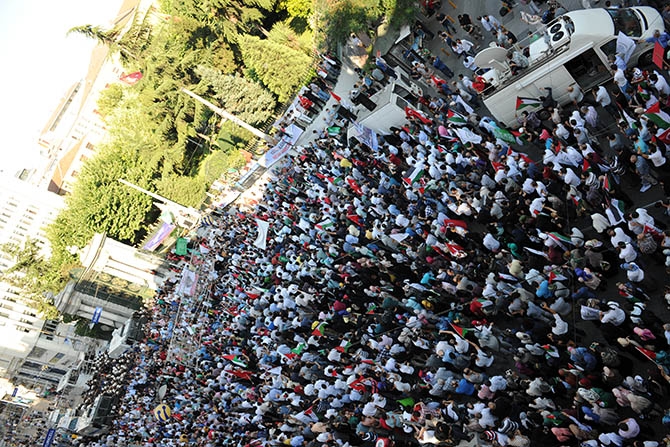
[475,6,664,127]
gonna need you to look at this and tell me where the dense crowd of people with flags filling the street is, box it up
[48,0,670,447]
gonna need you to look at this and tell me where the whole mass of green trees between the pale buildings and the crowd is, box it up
[39,0,418,320]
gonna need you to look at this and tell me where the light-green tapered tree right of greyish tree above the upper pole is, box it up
[238,35,312,102]
